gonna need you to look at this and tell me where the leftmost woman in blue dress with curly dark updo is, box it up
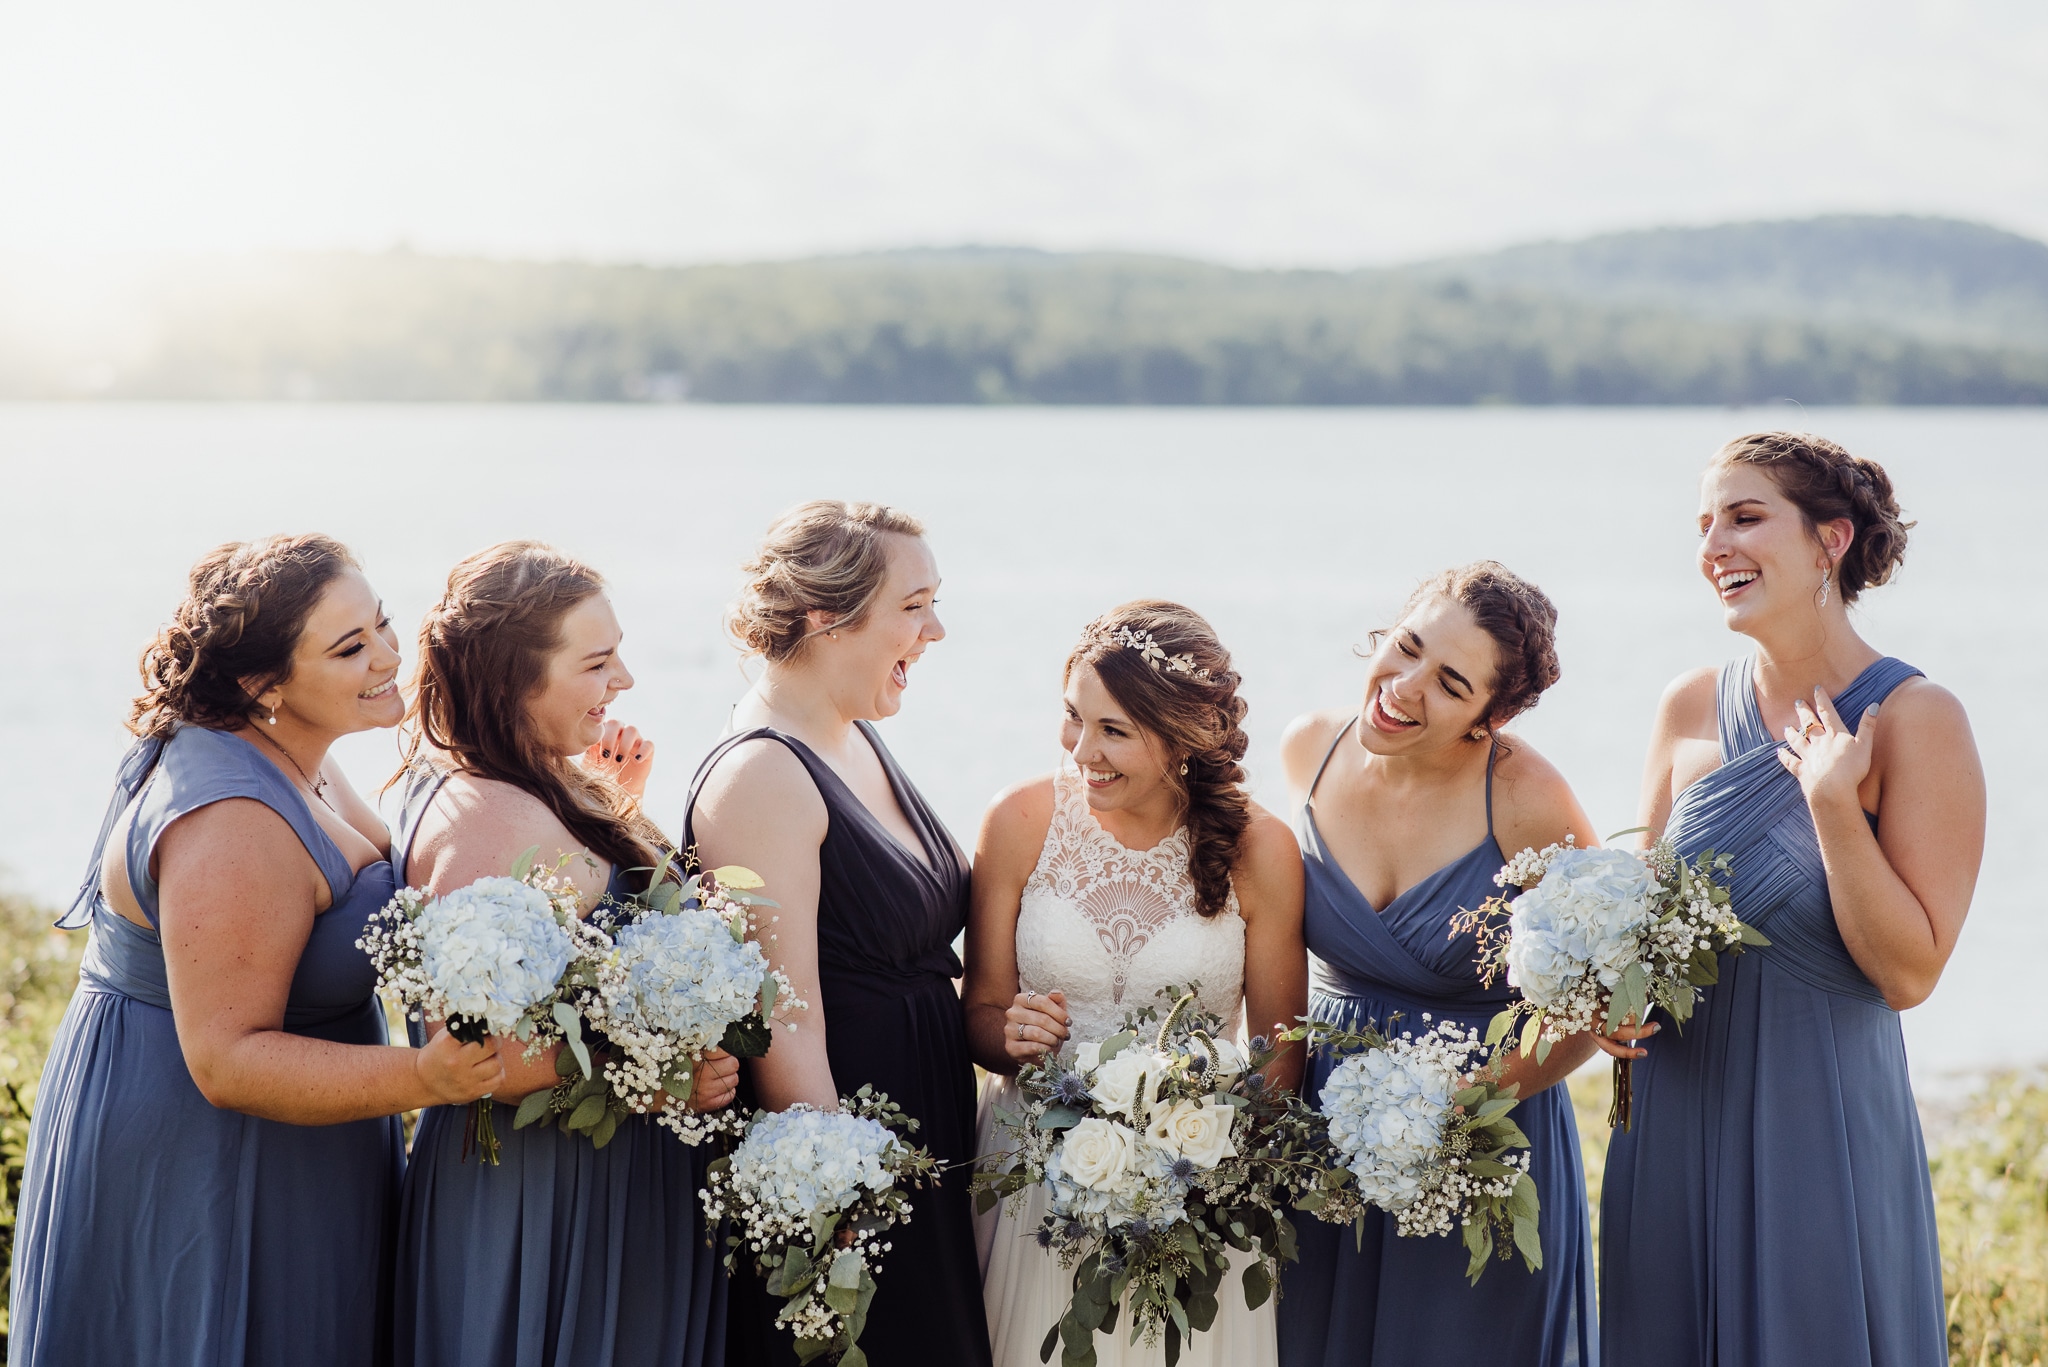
[8,535,504,1367]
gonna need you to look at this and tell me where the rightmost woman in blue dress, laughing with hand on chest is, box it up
[1599,432,1985,1367]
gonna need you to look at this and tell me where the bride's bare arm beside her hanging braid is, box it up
[1233,803,1309,1090]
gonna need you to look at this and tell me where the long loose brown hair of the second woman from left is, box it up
[406,541,668,871]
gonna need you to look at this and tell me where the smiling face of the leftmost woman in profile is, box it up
[256,570,406,736]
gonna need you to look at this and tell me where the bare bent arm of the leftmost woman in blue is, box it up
[156,797,504,1125]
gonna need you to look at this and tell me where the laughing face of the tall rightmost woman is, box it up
[1700,463,1851,635]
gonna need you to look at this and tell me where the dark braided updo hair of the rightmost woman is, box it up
[1714,432,1913,603]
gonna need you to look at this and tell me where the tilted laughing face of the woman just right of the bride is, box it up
[1358,594,1499,754]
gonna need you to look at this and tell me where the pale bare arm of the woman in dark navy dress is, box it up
[692,740,840,1111]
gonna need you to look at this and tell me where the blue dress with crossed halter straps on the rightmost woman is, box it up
[1599,658,1948,1367]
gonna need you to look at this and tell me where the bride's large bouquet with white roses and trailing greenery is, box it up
[975,986,1313,1367]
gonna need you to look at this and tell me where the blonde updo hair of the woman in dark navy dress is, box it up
[725,498,924,664]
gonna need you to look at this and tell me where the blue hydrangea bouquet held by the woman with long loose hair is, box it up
[512,859,803,1148]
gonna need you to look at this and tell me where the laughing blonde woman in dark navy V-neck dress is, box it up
[682,500,989,1367]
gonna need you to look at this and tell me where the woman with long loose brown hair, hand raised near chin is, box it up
[395,541,739,1367]
